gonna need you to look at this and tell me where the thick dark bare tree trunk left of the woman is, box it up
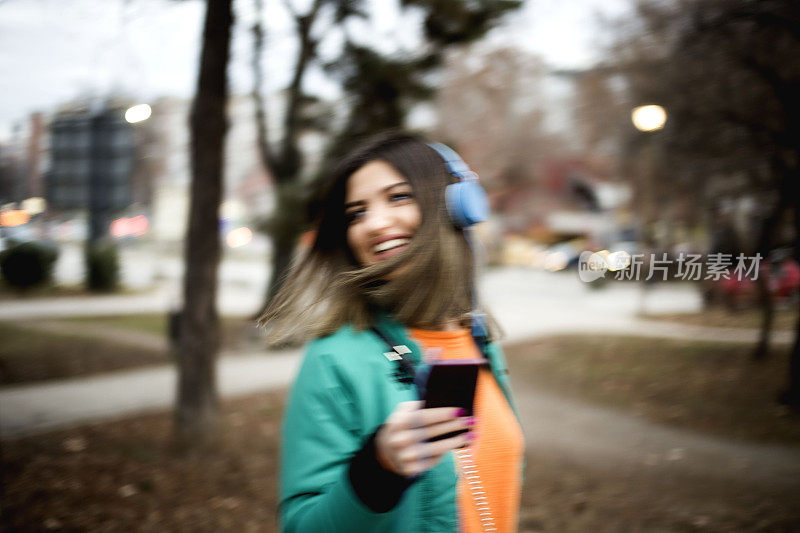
[175,0,233,446]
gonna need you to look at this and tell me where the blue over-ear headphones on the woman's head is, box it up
[428,143,489,228]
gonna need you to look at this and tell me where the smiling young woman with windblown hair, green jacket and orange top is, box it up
[261,133,524,533]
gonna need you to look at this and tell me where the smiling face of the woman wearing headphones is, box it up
[344,160,422,266]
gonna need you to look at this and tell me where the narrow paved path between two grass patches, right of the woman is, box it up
[514,384,800,490]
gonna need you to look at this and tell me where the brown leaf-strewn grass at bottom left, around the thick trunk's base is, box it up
[2,393,283,531]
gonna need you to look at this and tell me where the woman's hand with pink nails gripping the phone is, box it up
[375,401,474,477]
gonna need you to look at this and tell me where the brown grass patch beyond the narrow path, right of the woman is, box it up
[506,335,800,444]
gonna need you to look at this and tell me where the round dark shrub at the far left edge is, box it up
[0,241,58,289]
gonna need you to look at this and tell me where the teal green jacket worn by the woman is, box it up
[280,316,519,533]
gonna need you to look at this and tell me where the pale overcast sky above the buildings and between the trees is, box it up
[0,0,629,141]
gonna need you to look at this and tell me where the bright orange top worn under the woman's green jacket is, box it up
[411,329,525,533]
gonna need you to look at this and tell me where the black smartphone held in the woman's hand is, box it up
[417,359,486,442]
